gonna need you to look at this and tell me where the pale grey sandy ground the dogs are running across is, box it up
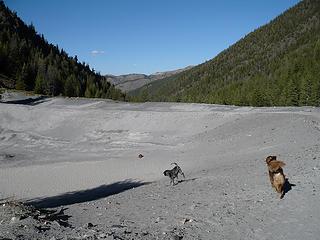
[0,95,320,240]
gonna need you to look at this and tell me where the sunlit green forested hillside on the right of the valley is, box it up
[131,0,320,106]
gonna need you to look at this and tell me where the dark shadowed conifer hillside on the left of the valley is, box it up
[0,1,125,100]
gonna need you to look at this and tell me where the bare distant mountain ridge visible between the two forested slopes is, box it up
[105,66,193,92]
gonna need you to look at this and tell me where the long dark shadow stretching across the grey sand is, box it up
[26,180,150,208]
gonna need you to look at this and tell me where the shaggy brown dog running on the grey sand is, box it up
[266,156,286,199]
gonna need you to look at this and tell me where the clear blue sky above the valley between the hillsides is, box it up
[5,0,299,75]
